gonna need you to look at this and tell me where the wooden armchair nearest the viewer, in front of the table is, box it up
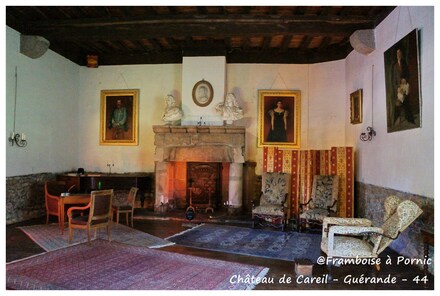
[67,189,113,243]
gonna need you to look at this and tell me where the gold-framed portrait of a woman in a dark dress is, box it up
[258,90,301,149]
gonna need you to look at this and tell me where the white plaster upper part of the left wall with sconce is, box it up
[4,27,79,176]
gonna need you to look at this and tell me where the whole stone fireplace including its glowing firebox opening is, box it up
[153,126,245,213]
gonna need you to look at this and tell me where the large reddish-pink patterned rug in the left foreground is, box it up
[6,240,269,290]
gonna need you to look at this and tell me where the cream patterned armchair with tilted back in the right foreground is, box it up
[321,196,423,270]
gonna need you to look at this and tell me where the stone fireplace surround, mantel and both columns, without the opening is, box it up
[153,126,245,213]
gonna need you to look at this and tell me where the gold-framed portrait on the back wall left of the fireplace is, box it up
[99,89,139,146]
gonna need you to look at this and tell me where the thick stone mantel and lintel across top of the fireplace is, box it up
[153,125,246,163]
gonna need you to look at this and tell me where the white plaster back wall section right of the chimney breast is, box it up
[226,60,345,174]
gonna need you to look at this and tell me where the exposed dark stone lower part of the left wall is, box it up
[6,173,56,224]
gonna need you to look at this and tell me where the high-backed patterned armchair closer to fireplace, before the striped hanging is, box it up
[252,173,290,231]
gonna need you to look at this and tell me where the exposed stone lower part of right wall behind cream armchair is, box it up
[355,182,434,273]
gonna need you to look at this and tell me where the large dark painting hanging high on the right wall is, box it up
[384,29,421,133]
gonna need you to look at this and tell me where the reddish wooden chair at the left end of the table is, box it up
[44,181,75,224]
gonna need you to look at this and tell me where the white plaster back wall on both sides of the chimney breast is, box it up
[78,61,345,173]
